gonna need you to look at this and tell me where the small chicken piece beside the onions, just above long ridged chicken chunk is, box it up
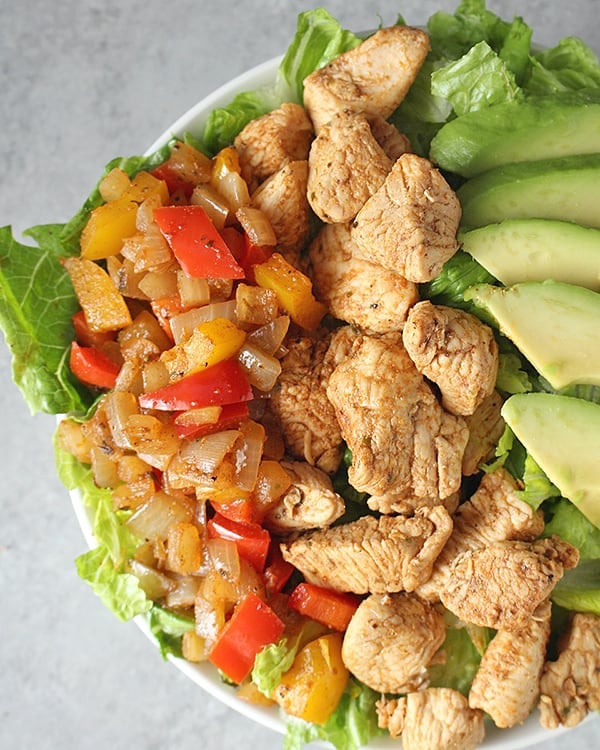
[263,461,345,535]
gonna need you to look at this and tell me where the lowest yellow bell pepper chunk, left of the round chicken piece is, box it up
[273,633,349,724]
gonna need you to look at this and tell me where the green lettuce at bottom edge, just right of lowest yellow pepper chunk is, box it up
[283,677,384,750]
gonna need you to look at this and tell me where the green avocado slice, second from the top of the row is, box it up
[457,153,600,228]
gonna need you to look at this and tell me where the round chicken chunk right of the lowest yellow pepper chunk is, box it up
[342,593,446,693]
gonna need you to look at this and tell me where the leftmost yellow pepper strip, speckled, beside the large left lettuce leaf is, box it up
[62,257,132,332]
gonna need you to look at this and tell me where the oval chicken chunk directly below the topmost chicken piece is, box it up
[308,112,392,224]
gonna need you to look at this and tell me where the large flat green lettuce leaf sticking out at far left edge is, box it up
[0,224,93,414]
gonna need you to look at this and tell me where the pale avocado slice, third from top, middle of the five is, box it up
[458,219,600,292]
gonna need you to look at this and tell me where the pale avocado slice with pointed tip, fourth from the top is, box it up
[464,281,600,390]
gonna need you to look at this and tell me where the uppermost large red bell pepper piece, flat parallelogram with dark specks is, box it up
[153,205,244,279]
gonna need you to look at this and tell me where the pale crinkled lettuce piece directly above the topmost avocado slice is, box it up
[431,42,523,116]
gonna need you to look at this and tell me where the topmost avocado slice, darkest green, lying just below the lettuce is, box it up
[430,92,600,177]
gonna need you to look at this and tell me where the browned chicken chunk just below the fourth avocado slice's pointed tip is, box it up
[402,300,498,416]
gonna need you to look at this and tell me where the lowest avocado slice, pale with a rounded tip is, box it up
[502,393,600,528]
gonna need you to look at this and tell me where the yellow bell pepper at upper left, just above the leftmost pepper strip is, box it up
[80,172,169,260]
